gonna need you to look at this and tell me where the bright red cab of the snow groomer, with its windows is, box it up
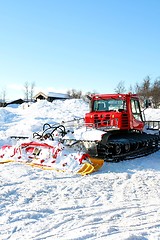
[85,93,144,131]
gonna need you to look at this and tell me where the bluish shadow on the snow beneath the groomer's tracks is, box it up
[100,151,160,173]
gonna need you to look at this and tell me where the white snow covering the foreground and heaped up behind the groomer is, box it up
[0,99,160,240]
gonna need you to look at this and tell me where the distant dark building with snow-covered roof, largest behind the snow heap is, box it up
[33,92,70,102]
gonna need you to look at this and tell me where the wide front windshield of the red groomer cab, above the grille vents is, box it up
[93,99,126,111]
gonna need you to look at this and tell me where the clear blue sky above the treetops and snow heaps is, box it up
[0,0,160,98]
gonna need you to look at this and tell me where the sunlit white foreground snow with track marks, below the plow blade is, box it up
[0,162,160,240]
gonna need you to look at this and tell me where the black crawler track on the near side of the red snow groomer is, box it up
[98,133,160,162]
